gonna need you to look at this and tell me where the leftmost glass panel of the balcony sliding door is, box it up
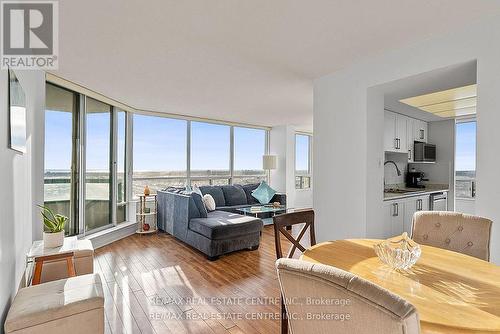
[44,84,78,235]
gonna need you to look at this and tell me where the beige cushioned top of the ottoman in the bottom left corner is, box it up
[5,274,104,333]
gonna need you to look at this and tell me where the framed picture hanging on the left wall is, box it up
[9,70,26,153]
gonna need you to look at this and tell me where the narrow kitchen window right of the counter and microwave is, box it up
[455,120,476,214]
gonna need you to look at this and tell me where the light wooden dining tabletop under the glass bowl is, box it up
[301,239,500,334]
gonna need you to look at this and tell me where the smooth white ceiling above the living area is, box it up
[53,0,500,130]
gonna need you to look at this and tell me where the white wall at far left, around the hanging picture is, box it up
[0,70,45,331]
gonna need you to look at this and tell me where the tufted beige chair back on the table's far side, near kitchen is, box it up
[412,211,492,261]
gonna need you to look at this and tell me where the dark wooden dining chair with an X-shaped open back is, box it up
[273,209,316,334]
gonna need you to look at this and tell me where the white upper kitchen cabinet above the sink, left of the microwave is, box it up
[384,111,408,153]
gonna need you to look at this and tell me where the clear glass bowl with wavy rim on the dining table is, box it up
[373,232,422,270]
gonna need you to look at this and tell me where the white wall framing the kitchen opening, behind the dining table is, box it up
[314,13,500,263]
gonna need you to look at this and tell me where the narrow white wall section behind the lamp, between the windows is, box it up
[269,125,313,208]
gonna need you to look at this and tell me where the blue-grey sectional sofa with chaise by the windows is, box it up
[158,184,286,260]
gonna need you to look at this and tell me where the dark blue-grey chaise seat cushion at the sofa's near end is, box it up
[189,210,263,240]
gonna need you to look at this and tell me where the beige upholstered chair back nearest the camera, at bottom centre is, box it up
[276,259,420,334]
